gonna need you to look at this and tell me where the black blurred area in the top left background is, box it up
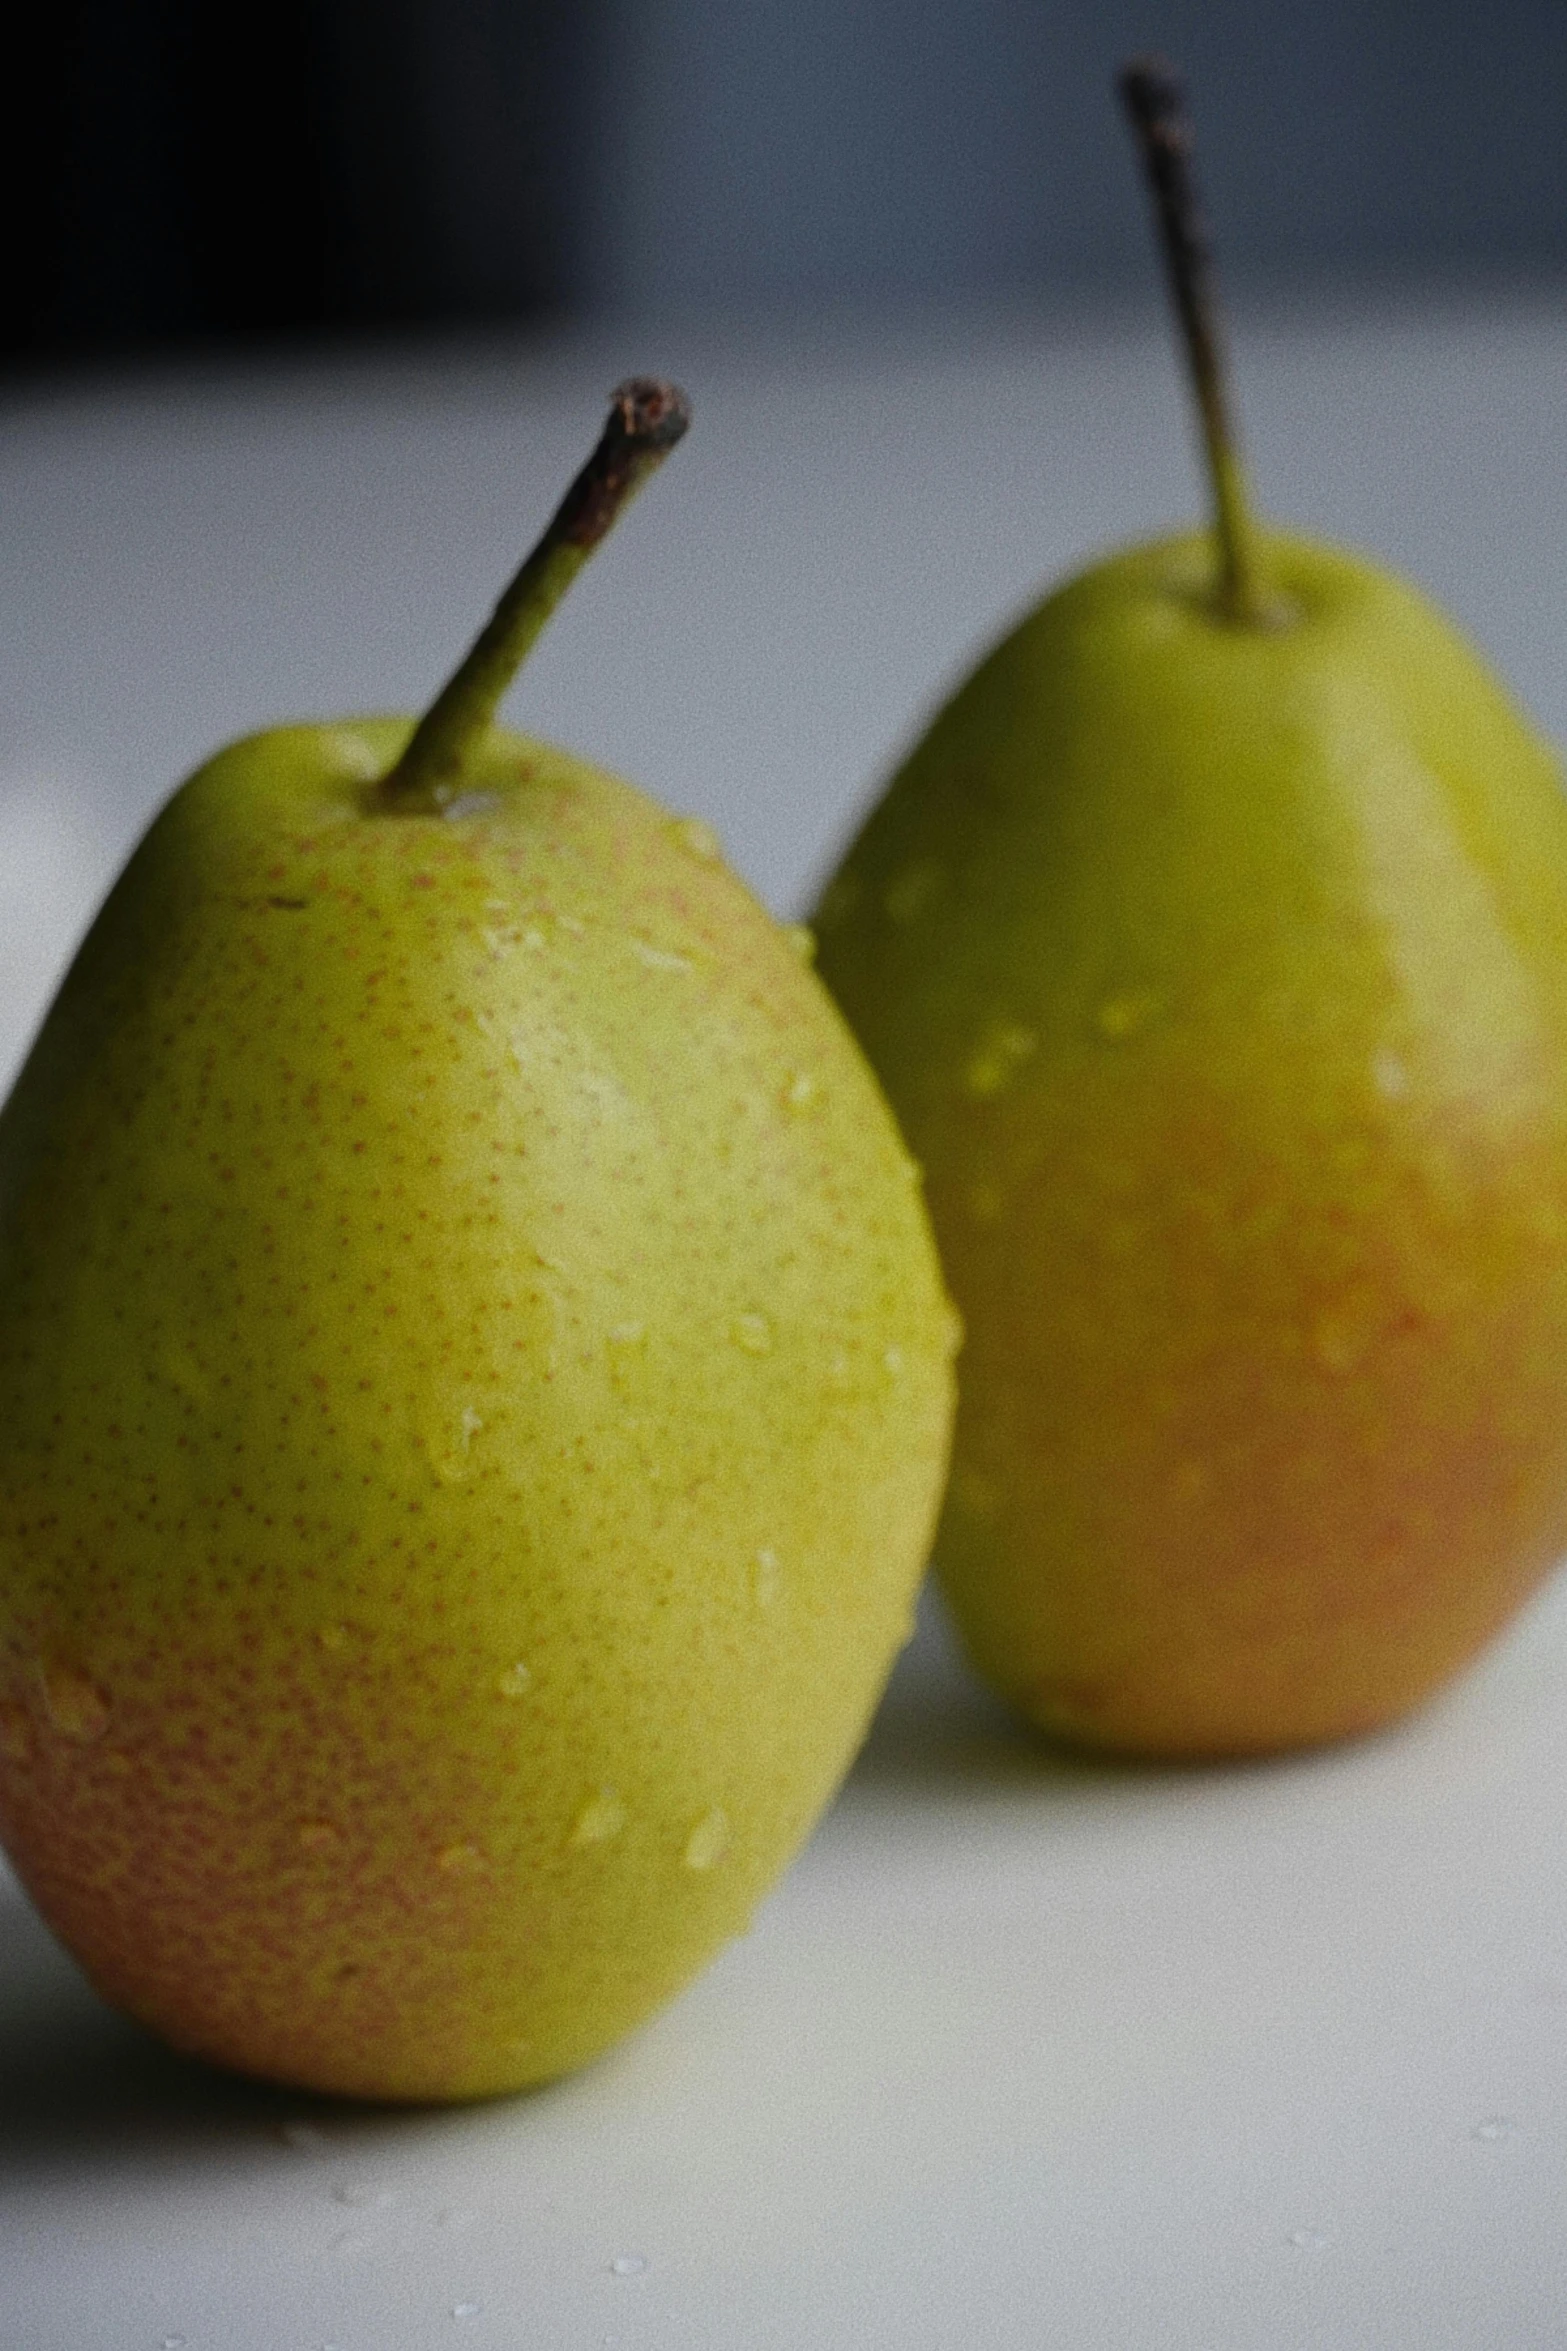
[0,0,594,360]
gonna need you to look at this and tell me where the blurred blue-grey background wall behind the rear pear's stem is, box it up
[576,0,1567,308]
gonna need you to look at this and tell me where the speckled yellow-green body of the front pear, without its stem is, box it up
[0,722,954,2099]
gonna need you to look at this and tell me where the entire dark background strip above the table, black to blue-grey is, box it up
[0,0,1567,362]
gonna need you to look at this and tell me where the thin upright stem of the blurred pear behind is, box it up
[1118,56,1271,628]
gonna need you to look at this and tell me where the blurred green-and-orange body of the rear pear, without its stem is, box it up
[820,534,1567,1756]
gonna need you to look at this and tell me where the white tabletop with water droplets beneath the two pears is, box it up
[0,308,1567,2351]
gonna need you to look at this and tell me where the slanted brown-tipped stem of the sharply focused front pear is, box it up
[376,376,691,816]
